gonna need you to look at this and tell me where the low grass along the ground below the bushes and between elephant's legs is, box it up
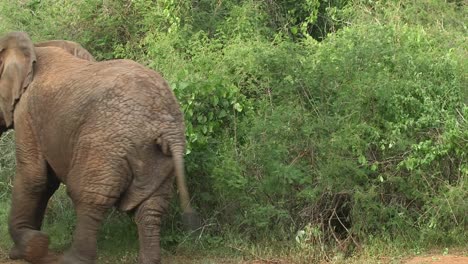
[0,194,468,264]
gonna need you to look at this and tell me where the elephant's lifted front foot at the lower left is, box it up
[9,230,49,263]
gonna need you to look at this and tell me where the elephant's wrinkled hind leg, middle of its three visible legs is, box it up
[60,160,125,264]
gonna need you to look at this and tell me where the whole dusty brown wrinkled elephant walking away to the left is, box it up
[0,32,198,264]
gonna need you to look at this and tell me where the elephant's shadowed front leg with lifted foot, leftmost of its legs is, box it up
[9,165,59,263]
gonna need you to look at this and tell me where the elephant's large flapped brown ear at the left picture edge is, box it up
[0,32,36,127]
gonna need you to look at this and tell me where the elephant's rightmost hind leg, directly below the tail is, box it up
[135,177,173,264]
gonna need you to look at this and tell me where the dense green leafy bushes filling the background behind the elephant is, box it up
[0,0,468,263]
